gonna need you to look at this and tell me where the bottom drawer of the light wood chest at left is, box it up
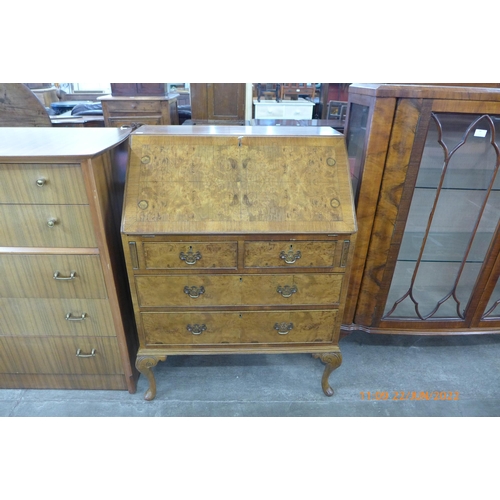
[0,336,123,375]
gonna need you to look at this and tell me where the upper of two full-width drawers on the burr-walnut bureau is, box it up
[135,273,343,307]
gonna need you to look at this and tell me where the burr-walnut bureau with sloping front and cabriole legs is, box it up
[121,126,356,400]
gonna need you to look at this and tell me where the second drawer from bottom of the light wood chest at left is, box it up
[0,298,115,337]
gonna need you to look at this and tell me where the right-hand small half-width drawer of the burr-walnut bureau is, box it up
[245,241,337,268]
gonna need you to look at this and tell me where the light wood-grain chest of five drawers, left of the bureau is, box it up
[0,127,139,393]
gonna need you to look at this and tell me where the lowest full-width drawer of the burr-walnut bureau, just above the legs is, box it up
[141,309,338,346]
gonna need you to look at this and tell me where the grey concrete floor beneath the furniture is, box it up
[0,332,500,417]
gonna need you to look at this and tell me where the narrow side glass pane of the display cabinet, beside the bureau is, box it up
[346,103,369,204]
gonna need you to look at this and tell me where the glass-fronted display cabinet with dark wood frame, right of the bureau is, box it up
[343,84,500,335]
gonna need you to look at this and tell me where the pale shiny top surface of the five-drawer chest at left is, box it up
[0,127,130,161]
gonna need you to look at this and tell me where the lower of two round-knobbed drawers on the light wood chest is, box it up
[0,205,97,248]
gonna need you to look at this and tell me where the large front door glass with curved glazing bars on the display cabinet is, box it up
[384,113,500,320]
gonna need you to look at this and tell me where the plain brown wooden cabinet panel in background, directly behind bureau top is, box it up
[190,83,246,121]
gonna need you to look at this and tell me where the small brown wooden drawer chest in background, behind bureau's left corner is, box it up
[98,94,179,127]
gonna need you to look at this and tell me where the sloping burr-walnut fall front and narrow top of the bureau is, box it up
[122,126,356,234]
